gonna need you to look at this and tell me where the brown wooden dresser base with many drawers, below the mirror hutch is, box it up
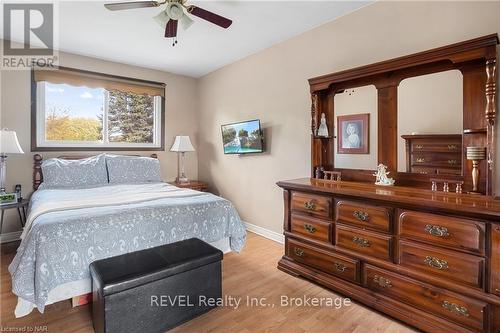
[278,178,500,332]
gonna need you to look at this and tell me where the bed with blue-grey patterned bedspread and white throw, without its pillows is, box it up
[9,155,246,317]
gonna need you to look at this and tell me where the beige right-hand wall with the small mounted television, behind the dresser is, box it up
[199,1,500,232]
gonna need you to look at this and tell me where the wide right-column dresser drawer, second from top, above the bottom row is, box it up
[399,241,484,288]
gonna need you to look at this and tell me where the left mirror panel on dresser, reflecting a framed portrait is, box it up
[333,85,377,170]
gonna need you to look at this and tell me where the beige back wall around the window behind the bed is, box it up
[0,49,198,233]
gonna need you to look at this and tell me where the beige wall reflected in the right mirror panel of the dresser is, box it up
[398,69,464,172]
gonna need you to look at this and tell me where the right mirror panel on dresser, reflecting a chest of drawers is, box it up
[397,69,463,175]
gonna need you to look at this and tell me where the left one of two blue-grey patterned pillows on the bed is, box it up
[42,154,108,188]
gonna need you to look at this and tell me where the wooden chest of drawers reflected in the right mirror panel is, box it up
[402,134,462,175]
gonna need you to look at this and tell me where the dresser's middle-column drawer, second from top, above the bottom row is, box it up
[335,224,392,261]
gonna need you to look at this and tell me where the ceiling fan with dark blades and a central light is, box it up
[104,0,233,46]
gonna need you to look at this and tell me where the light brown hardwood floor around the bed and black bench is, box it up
[0,233,415,333]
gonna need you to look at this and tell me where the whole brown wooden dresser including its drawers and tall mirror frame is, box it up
[284,34,500,333]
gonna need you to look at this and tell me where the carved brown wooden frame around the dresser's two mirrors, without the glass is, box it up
[309,34,499,195]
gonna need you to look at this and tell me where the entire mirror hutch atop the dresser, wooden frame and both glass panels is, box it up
[309,34,498,195]
